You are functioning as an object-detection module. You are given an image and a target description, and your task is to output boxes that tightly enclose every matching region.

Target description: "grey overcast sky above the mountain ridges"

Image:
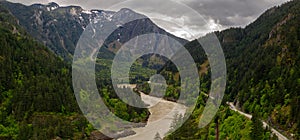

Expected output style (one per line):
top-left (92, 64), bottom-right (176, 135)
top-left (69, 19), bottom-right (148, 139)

top-left (8, 0), bottom-right (288, 40)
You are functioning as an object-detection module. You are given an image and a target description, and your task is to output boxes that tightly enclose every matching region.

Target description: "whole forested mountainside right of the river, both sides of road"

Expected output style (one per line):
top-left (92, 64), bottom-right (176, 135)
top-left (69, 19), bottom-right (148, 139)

top-left (152, 0), bottom-right (300, 139)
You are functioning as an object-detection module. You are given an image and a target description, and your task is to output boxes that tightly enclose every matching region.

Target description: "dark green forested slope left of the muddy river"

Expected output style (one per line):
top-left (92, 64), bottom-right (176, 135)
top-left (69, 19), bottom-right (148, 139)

top-left (0, 4), bottom-right (149, 140)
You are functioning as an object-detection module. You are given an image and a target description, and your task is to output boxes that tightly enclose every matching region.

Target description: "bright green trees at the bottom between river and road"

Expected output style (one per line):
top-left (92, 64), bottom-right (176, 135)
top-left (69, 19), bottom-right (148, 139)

top-left (165, 106), bottom-right (275, 140)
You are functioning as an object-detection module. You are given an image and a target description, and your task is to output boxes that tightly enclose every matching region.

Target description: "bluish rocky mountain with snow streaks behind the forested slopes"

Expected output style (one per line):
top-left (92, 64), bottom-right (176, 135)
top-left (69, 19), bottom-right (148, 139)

top-left (1, 1), bottom-right (187, 60)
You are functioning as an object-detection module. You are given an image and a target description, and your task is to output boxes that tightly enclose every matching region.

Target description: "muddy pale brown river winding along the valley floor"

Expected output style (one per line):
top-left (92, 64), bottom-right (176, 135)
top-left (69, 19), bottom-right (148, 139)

top-left (119, 86), bottom-right (187, 140)
